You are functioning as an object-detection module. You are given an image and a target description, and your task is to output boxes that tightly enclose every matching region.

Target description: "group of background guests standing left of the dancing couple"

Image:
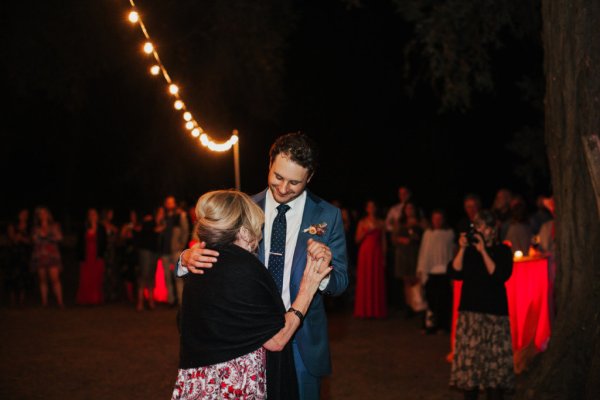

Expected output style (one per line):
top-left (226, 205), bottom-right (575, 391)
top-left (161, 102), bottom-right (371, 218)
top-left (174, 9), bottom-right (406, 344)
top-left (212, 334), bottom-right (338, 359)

top-left (2, 196), bottom-right (194, 310)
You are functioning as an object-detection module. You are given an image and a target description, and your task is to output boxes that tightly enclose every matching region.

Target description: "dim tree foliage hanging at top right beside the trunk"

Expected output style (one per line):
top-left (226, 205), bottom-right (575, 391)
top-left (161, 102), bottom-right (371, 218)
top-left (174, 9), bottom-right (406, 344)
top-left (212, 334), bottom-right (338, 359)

top-left (393, 0), bottom-right (540, 111)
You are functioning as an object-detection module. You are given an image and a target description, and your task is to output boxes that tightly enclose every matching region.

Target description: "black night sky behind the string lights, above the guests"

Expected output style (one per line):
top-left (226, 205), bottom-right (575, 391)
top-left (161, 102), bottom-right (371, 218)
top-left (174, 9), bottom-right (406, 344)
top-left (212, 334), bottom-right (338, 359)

top-left (0, 0), bottom-right (547, 228)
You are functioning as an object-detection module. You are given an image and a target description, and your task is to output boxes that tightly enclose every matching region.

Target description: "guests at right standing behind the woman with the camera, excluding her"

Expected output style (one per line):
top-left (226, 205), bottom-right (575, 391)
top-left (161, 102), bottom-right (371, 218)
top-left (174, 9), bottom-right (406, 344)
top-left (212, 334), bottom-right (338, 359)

top-left (337, 186), bottom-right (554, 334)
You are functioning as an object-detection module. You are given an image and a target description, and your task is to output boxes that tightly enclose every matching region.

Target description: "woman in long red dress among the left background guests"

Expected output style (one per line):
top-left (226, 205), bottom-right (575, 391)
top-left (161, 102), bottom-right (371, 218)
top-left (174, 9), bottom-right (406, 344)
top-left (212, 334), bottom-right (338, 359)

top-left (76, 208), bottom-right (106, 304)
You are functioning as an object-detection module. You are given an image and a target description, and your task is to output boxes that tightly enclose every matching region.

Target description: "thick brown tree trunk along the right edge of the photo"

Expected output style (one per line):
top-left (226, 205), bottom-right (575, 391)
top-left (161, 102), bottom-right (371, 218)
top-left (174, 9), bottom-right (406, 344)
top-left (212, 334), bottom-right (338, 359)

top-left (517, 0), bottom-right (600, 400)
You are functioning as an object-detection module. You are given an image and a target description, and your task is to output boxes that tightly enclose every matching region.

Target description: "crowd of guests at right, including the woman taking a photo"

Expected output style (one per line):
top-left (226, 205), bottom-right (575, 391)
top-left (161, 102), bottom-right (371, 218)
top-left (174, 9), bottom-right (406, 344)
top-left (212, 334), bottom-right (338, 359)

top-left (343, 187), bottom-right (554, 399)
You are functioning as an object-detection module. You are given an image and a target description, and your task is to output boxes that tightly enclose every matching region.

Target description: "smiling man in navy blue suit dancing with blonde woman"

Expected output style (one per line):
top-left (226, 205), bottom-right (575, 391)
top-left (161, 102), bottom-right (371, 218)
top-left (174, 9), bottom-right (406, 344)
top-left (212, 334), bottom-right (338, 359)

top-left (178, 132), bottom-right (348, 400)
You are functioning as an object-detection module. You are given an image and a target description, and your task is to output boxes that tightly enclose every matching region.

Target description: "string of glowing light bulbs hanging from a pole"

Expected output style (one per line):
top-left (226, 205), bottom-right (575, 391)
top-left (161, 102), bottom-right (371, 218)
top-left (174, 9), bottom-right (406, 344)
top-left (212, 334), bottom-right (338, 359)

top-left (128, 0), bottom-right (239, 152)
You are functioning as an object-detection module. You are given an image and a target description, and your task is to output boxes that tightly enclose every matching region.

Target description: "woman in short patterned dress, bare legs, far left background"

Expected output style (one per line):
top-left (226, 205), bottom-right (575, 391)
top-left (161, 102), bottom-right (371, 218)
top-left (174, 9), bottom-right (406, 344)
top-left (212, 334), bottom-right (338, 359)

top-left (31, 207), bottom-right (64, 308)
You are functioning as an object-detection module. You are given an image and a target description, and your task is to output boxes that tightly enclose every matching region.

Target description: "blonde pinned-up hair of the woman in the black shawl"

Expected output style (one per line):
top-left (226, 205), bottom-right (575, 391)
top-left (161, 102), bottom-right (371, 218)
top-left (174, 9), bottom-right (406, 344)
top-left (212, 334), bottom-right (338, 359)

top-left (195, 190), bottom-right (265, 247)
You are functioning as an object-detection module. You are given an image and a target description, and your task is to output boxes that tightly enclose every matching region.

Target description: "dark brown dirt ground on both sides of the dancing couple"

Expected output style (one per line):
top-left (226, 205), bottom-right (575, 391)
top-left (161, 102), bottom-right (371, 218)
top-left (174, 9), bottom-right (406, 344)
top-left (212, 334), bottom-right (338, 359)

top-left (0, 303), bottom-right (510, 400)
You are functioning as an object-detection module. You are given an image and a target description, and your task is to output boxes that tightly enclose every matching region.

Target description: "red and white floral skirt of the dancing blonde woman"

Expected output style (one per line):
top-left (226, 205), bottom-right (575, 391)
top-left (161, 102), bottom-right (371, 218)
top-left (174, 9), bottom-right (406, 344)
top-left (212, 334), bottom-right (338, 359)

top-left (171, 347), bottom-right (267, 400)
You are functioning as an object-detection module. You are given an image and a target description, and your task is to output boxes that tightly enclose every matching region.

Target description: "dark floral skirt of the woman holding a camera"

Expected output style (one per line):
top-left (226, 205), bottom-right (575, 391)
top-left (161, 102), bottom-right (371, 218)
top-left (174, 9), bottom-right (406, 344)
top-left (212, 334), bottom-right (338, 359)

top-left (450, 311), bottom-right (515, 390)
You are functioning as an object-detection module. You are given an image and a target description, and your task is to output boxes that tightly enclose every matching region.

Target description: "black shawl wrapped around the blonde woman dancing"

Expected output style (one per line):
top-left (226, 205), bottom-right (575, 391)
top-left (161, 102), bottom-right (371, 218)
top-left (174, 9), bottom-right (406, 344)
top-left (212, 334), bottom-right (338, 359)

top-left (179, 244), bottom-right (298, 399)
